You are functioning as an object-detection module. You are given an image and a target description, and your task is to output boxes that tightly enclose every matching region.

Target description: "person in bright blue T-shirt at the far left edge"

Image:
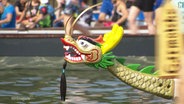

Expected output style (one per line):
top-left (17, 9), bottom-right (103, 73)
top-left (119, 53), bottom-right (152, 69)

top-left (0, 0), bottom-right (16, 28)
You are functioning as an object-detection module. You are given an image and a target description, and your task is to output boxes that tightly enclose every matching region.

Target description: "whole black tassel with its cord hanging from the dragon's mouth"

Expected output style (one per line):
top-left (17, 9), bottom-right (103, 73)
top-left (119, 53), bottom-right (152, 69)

top-left (60, 61), bottom-right (67, 101)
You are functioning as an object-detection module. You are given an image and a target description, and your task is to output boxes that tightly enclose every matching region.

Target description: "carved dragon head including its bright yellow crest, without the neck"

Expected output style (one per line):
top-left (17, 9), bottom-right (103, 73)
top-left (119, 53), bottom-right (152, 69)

top-left (61, 24), bottom-right (123, 67)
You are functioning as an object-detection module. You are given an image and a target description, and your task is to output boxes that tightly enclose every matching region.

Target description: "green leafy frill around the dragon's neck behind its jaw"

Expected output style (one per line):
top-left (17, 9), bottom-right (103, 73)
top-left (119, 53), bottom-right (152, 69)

top-left (87, 52), bottom-right (116, 69)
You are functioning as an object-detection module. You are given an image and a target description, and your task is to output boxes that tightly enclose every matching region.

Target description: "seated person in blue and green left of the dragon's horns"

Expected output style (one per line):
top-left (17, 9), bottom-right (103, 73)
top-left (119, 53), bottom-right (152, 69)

top-left (28, 0), bottom-right (55, 28)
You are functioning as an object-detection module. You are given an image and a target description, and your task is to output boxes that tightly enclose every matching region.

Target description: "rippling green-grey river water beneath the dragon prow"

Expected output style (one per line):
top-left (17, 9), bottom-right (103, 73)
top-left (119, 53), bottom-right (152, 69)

top-left (0, 56), bottom-right (174, 104)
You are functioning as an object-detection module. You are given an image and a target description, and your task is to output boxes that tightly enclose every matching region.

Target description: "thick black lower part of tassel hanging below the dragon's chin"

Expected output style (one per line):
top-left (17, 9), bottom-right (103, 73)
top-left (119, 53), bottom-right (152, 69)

top-left (60, 73), bottom-right (67, 101)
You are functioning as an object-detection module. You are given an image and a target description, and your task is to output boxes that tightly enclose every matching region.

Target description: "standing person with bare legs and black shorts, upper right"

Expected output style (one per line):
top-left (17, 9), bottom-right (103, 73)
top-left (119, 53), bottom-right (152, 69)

top-left (128, 0), bottom-right (155, 35)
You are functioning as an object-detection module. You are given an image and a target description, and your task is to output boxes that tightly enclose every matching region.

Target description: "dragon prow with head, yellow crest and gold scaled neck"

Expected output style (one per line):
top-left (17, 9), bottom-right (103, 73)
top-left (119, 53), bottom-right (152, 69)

top-left (61, 25), bottom-right (175, 99)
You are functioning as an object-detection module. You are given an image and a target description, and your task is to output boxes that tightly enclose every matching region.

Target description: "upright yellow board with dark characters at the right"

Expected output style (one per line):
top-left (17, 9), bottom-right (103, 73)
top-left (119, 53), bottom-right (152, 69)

top-left (155, 0), bottom-right (183, 78)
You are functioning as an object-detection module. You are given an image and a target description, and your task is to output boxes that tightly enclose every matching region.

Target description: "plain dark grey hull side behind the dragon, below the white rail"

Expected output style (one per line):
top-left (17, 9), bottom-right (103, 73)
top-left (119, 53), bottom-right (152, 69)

top-left (0, 35), bottom-right (154, 56)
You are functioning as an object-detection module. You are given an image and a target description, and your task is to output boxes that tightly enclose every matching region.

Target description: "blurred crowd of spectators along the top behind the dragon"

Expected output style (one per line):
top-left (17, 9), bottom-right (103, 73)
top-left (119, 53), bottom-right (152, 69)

top-left (0, 0), bottom-right (162, 34)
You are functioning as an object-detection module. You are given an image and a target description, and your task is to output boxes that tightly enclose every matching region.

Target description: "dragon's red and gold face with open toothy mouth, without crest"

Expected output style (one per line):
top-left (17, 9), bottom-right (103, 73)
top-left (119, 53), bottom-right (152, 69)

top-left (61, 35), bottom-right (102, 63)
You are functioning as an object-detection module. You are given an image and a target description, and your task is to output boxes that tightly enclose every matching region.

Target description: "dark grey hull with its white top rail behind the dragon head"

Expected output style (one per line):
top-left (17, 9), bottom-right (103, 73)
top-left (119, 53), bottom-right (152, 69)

top-left (0, 28), bottom-right (154, 56)
